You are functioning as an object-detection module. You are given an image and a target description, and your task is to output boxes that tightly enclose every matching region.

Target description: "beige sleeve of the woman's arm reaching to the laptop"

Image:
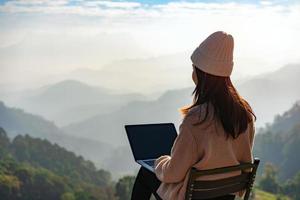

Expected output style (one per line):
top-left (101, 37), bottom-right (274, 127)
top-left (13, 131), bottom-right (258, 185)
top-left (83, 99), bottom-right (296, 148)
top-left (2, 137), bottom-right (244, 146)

top-left (154, 123), bottom-right (197, 183)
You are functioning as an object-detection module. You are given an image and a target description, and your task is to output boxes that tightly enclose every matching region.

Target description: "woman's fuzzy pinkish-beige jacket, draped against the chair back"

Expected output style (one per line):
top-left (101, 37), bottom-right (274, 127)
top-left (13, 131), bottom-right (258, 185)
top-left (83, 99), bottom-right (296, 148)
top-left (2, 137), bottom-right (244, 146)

top-left (155, 104), bottom-right (254, 200)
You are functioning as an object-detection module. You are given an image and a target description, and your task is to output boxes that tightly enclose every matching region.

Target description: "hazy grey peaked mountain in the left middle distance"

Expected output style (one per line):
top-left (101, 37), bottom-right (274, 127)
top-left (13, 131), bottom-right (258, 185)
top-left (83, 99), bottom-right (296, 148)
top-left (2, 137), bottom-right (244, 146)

top-left (2, 80), bottom-right (147, 125)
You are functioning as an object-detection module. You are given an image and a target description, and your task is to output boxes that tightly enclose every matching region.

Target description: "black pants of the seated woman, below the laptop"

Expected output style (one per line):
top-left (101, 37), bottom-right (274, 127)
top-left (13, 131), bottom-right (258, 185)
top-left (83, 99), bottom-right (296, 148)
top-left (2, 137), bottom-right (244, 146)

top-left (131, 167), bottom-right (235, 200)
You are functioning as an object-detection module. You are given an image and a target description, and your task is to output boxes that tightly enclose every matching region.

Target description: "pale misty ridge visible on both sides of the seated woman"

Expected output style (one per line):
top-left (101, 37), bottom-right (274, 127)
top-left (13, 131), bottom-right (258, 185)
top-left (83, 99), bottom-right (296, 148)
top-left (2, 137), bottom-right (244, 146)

top-left (62, 65), bottom-right (300, 144)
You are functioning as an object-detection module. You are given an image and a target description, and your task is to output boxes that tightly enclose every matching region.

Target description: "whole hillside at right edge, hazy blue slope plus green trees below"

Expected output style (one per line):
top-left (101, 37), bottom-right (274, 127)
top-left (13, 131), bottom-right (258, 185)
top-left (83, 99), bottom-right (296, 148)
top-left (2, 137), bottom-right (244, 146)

top-left (254, 102), bottom-right (300, 200)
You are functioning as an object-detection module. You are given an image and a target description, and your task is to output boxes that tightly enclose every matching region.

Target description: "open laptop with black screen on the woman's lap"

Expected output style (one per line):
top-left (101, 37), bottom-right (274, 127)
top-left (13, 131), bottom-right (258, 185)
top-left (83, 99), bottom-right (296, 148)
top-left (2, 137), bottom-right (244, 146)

top-left (125, 123), bottom-right (177, 172)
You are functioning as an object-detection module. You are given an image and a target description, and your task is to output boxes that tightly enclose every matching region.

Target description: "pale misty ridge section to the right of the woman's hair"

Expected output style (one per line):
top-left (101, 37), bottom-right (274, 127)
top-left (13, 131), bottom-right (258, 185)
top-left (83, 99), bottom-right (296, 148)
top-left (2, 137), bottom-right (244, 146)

top-left (236, 64), bottom-right (300, 127)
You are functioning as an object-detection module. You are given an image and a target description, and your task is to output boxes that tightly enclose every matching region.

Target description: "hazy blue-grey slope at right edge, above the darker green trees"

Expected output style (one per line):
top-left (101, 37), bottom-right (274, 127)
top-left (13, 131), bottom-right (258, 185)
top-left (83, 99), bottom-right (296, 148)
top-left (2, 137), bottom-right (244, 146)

top-left (254, 102), bottom-right (300, 180)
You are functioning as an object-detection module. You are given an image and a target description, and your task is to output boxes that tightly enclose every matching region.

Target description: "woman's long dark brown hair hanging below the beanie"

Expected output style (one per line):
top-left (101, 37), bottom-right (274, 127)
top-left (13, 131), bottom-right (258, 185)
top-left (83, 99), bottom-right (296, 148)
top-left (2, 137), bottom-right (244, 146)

top-left (181, 67), bottom-right (256, 138)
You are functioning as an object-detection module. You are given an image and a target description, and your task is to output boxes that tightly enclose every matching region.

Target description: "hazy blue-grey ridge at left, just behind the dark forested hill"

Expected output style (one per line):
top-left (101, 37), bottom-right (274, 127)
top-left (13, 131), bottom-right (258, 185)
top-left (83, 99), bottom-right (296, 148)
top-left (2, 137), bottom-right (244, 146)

top-left (0, 101), bottom-right (112, 170)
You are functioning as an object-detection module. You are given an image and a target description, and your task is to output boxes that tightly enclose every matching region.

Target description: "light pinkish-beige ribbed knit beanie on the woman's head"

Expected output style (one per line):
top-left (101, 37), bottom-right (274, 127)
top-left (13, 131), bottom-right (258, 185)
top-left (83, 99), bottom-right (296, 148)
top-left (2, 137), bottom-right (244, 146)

top-left (191, 31), bottom-right (234, 77)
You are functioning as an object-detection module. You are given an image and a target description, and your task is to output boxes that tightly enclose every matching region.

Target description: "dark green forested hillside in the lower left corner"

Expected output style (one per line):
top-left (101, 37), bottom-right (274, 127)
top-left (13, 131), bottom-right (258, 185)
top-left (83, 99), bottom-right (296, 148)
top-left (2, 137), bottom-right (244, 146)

top-left (0, 128), bottom-right (115, 200)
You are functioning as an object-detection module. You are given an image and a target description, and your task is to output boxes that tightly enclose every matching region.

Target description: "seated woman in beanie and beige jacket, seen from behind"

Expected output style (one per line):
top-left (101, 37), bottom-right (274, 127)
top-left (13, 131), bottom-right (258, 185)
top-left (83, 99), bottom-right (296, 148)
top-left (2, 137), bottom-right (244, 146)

top-left (132, 31), bottom-right (256, 200)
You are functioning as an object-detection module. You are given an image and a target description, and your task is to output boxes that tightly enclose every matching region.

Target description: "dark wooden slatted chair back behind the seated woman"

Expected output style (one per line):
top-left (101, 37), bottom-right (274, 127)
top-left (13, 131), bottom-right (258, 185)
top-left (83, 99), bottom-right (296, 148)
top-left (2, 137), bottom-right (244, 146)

top-left (185, 158), bottom-right (260, 200)
